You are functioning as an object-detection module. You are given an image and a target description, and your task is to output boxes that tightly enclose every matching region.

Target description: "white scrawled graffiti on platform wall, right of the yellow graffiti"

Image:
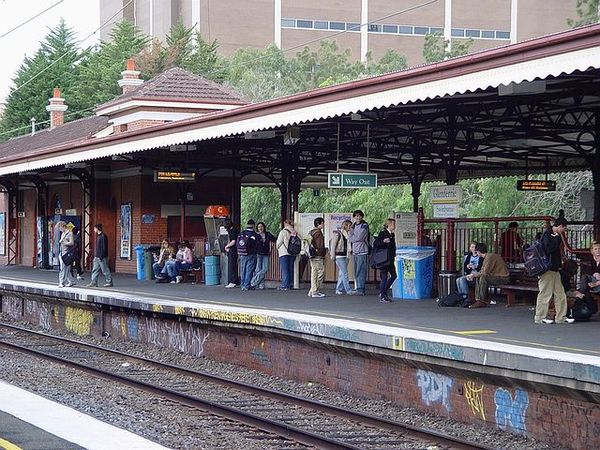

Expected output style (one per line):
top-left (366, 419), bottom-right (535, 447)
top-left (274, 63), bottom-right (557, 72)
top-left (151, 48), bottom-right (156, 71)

top-left (145, 317), bottom-right (209, 356)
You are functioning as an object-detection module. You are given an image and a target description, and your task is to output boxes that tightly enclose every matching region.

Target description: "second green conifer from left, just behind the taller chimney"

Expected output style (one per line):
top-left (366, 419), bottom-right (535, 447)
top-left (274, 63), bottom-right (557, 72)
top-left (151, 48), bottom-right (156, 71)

top-left (73, 20), bottom-right (149, 114)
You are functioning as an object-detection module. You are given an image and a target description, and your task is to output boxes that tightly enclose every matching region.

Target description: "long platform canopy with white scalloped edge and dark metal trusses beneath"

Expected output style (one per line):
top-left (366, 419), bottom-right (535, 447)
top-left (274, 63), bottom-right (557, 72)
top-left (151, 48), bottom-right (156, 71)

top-left (0, 25), bottom-right (600, 185)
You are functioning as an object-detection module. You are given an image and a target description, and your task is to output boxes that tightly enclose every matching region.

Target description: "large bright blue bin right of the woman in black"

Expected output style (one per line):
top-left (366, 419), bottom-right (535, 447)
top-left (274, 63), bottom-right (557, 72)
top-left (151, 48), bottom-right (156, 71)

top-left (392, 246), bottom-right (435, 300)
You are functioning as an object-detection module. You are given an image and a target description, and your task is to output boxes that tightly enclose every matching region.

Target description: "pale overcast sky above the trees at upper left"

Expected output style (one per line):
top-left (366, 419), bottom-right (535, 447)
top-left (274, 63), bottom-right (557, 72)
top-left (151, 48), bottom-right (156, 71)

top-left (0, 0), bottom-right (100, 102)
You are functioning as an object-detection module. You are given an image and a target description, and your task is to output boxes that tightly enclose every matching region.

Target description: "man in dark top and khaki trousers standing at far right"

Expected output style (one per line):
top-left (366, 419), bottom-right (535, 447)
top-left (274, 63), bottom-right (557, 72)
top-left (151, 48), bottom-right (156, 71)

top-left (533, 217), bottom-right (574, 324)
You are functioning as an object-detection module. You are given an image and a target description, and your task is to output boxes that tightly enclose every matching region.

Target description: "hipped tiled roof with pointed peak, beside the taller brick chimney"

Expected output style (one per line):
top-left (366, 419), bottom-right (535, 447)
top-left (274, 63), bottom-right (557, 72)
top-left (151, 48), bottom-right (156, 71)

top-left (97, 67), bottom-right (248, 109)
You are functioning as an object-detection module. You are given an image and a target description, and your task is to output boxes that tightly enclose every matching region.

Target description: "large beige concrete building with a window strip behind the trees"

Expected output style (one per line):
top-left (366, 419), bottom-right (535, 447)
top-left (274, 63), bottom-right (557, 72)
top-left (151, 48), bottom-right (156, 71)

top-left (100, 0), bottom-right (577, 65)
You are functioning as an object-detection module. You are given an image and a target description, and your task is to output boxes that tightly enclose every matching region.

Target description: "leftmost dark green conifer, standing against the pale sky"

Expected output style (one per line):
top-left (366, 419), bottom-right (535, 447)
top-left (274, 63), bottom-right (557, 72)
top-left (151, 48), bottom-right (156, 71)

top-left (0, 20), bottom-right (81, 140)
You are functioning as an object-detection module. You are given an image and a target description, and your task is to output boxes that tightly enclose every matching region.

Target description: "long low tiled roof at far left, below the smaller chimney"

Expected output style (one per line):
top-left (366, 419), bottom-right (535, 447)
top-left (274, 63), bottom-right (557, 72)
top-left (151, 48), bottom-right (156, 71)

top-left (0, 116), bottom-right (108, 160)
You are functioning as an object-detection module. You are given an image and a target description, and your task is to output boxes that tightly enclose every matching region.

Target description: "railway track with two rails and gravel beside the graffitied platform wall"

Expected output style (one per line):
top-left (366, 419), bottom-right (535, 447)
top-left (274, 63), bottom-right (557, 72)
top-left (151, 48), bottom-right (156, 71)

top-left (0, 323), bottom-right (490, 450)
